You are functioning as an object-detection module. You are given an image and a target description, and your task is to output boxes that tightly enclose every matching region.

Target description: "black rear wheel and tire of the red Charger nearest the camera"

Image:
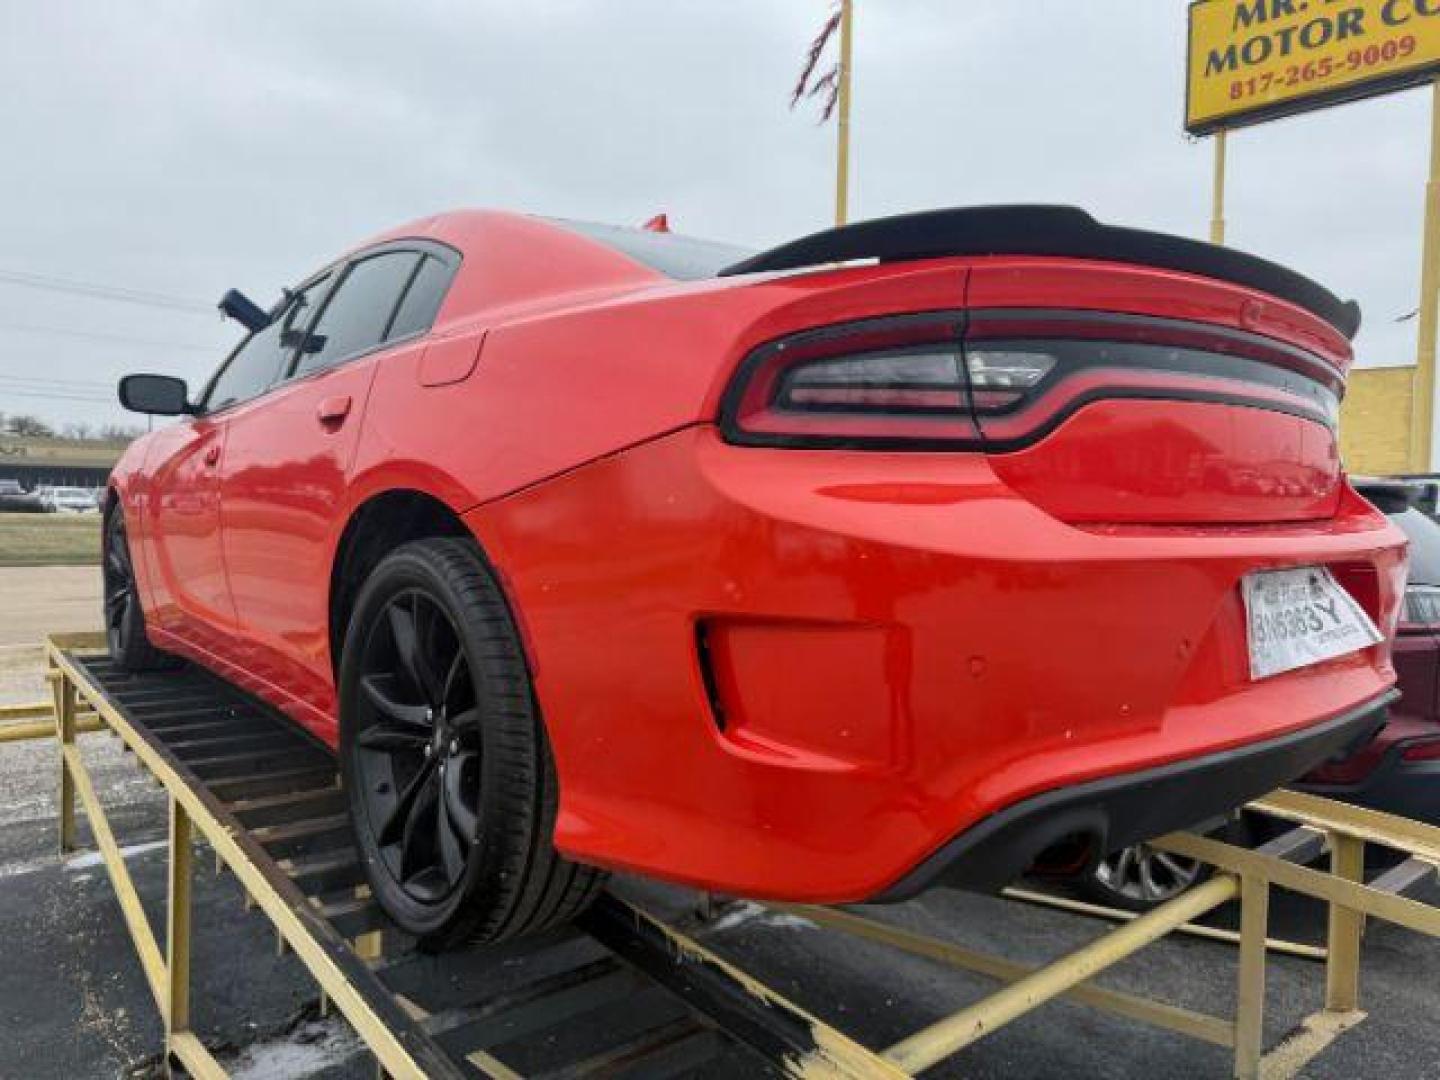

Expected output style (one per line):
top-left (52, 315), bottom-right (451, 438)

top-left (340, 539), bottom-right (606, 952)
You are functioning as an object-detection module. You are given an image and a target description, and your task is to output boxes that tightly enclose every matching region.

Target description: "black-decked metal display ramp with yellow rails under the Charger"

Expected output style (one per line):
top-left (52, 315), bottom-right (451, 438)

top-left (19, 635), bottom-right (1440, 1077)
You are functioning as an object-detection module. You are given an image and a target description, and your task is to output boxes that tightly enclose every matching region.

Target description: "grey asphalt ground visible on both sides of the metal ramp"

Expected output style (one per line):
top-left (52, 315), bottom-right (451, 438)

top-left (0, 572), bottom-right (1440, 1080)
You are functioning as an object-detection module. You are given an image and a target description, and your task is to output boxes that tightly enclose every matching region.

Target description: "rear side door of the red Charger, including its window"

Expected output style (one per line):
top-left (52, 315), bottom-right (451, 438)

top-left (220, 245), bottom-right (443, 734)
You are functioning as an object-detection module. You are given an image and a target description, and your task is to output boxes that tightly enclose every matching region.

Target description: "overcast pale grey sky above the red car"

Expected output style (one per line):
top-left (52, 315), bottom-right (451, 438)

top-left (0, 0), bottom-right (1428, 423)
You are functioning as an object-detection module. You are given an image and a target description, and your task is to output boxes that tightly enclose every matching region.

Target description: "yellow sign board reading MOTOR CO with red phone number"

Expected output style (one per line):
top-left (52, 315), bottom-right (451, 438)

top-left (1185, 0), bottom-right (1440, 135)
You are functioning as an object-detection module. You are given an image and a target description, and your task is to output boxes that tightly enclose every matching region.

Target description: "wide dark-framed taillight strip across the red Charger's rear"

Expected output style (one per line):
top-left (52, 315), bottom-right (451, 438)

top-left (721, 311), bottom-right (1341, 451)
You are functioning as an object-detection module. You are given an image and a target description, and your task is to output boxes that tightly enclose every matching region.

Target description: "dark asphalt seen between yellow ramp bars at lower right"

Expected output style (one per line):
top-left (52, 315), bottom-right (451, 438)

top-left (707, 888), bottom-right (1440, 1080)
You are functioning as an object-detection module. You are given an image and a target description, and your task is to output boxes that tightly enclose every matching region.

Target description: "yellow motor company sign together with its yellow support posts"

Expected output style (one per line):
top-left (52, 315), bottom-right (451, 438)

top-left (1185, 0), bottom-right (1440, 472)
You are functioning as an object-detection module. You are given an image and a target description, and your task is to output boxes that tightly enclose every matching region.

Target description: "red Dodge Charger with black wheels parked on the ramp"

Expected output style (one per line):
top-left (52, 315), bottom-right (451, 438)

top-left (105, 206), bottom-right (1405, 946)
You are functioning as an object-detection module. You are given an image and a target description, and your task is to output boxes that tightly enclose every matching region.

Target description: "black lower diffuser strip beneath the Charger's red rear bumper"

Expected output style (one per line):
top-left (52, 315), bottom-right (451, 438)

top-left (873, 693), bottom-right (1388, 903)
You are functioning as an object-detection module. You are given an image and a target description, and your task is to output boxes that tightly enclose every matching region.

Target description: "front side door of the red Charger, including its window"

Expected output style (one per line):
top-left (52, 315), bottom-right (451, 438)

top-left (144, 292), bottom-right (322, 658)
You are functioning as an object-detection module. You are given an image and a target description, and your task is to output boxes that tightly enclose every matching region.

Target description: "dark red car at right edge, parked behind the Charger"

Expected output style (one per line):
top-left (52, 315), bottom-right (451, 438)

top-left (1073, 478), bottom-right (1440, 910)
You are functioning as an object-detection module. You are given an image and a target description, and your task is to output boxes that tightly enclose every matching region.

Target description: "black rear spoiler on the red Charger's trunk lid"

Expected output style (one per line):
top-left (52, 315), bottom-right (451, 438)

top-left (720, 206), bottom-right (1361, 338)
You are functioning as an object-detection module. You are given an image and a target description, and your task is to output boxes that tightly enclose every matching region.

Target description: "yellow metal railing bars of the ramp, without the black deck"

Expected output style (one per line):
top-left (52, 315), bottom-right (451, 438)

top-left (16, 638), bottom-right (1440, 1079)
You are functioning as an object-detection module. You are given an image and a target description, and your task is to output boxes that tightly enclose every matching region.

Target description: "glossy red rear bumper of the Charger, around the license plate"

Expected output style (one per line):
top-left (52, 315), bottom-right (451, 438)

top-left (467, 428), bottom-right (1404, 903)
